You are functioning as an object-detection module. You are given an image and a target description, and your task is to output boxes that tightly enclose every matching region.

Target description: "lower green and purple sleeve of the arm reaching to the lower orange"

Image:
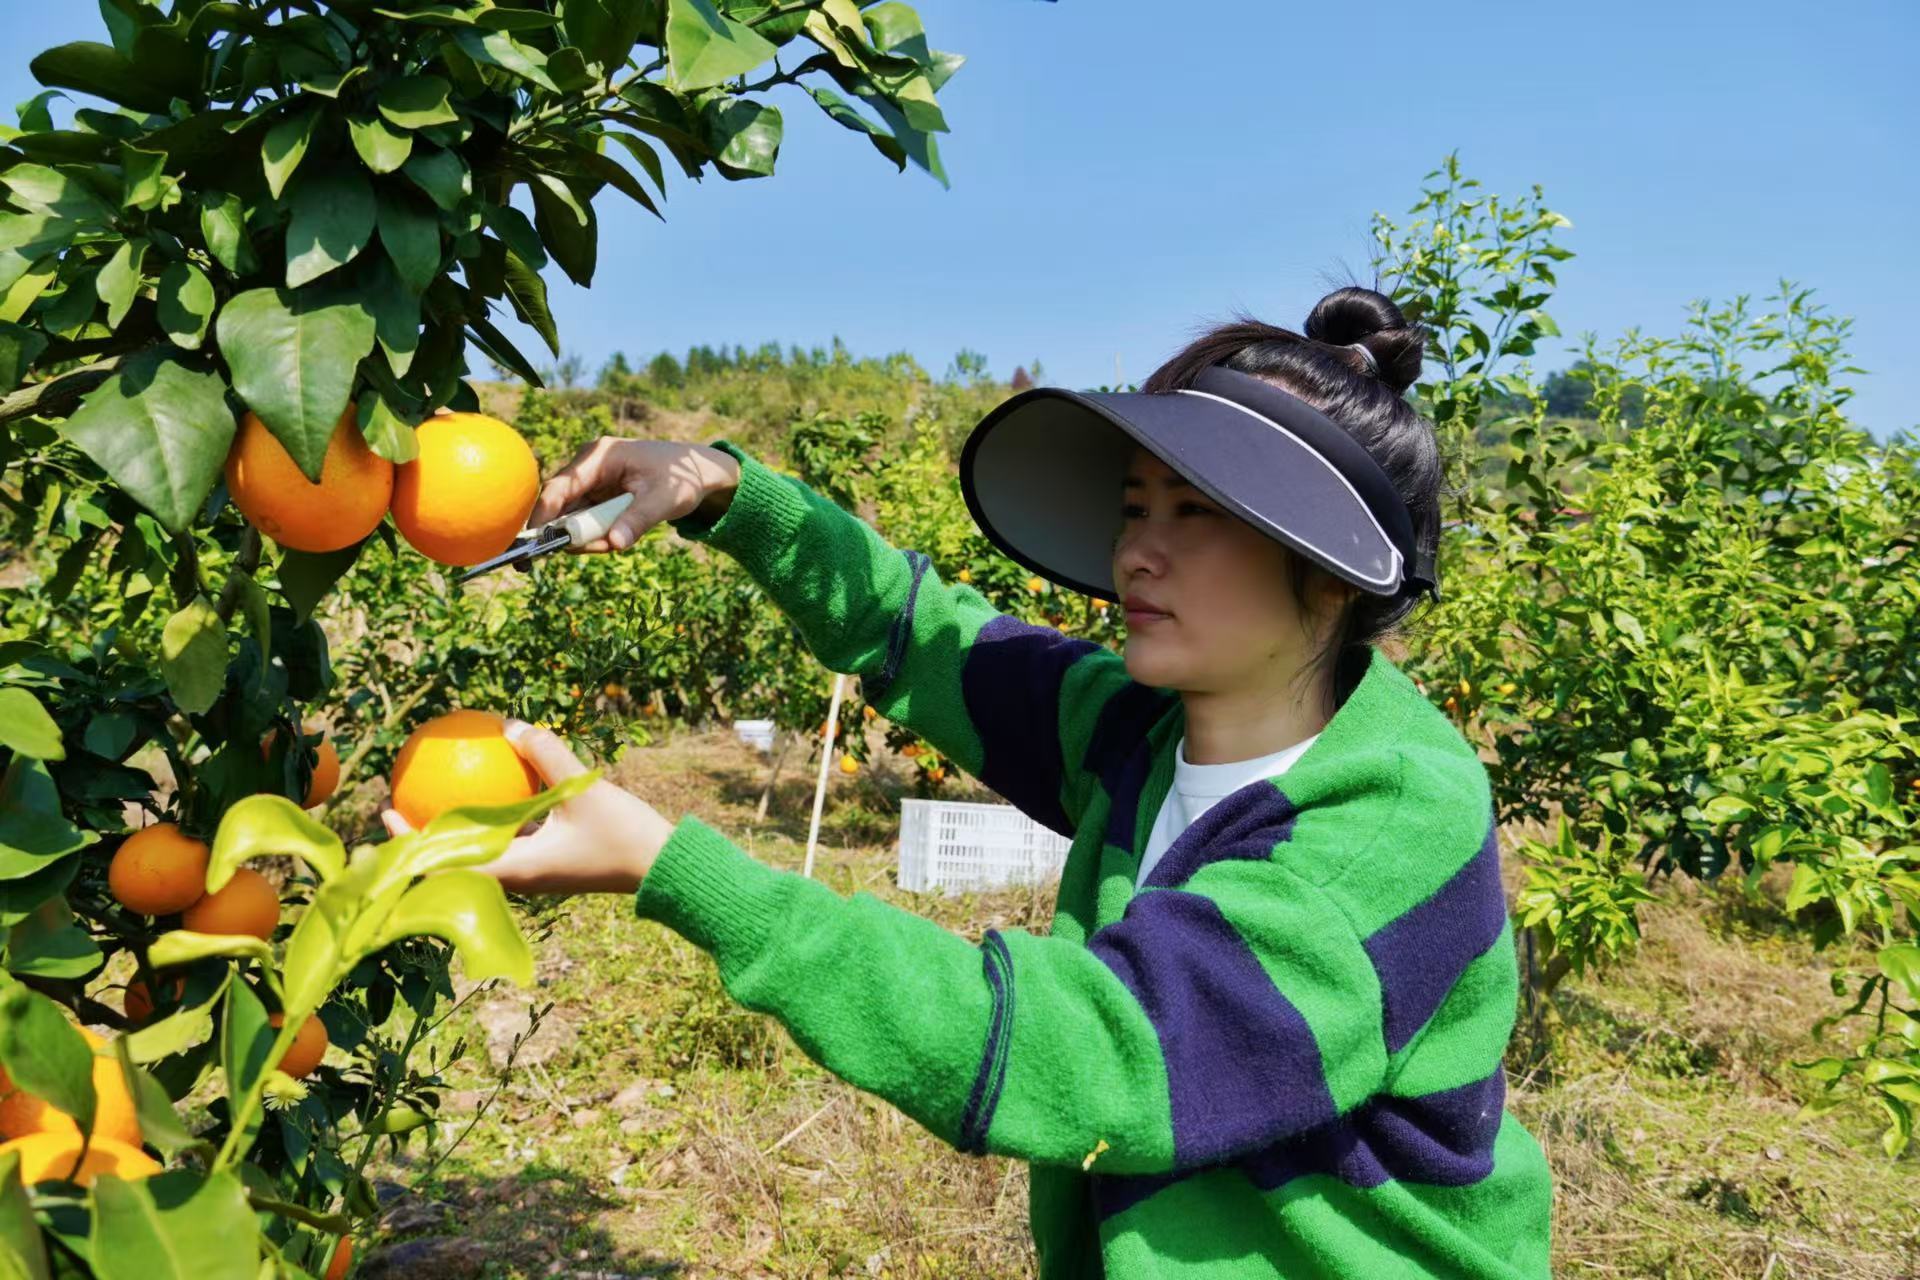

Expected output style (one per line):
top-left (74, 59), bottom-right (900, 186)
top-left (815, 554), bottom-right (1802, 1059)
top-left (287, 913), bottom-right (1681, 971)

top-left (636, 802), bottom-right (1386, 1174)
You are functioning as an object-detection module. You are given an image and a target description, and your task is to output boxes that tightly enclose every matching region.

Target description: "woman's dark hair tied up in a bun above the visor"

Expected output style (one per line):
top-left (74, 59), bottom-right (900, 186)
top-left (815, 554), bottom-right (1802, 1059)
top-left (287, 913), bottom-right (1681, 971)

top-left (1140, 286), bottom-right (1446, 714)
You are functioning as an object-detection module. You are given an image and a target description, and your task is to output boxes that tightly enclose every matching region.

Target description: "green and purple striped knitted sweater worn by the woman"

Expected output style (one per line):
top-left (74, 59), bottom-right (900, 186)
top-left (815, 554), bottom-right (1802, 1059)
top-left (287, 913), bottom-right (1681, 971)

top-left (634, 441), bottom-right (1551, 1280)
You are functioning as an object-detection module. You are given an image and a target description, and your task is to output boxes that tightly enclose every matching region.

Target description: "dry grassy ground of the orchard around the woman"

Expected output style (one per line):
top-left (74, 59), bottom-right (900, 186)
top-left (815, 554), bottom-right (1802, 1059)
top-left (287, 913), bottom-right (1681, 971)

top-left (345, 733), bottom-right (1920, 1280)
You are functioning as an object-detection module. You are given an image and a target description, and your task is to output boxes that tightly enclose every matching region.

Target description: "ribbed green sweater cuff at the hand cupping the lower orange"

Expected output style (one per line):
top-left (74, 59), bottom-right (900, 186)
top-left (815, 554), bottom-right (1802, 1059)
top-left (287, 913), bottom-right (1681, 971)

top-left (634, 814), bottom-right (791, 969)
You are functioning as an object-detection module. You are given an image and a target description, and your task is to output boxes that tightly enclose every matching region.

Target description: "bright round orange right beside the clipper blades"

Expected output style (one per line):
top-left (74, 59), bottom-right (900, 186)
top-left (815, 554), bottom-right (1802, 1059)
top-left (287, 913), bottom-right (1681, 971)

top-left (394, 413), bottom-right (540, 566)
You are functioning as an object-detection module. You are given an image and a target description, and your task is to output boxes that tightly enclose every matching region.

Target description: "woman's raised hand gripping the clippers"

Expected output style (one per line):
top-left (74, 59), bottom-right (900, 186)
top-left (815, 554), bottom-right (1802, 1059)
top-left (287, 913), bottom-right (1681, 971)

top-left (526, 436), bottom-right (739, 555)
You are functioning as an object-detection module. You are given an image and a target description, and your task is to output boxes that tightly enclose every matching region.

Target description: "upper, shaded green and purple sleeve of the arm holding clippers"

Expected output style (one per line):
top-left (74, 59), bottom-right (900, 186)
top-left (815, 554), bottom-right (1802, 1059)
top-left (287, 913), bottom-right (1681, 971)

top-left (674, 439), bottom-right (1173, 835)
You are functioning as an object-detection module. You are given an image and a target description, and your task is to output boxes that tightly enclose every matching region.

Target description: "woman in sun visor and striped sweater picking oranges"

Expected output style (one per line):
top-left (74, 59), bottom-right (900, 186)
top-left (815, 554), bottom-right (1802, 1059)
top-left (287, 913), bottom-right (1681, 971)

top-left (397, 288), bottom-right (1551, 1280)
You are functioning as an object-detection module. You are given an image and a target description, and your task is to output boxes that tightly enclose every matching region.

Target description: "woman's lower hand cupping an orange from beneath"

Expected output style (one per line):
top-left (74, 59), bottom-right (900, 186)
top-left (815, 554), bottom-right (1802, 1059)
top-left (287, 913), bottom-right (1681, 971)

top-left (380, 720), bottom-right (674, 894)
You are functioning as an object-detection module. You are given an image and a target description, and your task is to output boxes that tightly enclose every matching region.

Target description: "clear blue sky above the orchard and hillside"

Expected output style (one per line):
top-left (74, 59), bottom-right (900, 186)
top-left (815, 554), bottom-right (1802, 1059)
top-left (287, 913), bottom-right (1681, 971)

top-left (0, 0), bottom-right (1920, 439)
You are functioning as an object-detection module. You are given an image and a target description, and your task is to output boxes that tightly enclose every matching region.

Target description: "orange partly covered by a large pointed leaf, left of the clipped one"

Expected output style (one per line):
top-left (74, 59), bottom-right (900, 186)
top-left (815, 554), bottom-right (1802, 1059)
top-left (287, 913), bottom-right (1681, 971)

top-left (227, 405), bottom-right (394, 551)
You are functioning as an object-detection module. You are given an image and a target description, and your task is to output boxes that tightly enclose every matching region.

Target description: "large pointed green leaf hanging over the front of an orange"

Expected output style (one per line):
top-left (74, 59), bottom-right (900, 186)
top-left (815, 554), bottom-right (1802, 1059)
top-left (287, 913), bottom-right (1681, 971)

top-left (213, 290), bottom-right (374, 484)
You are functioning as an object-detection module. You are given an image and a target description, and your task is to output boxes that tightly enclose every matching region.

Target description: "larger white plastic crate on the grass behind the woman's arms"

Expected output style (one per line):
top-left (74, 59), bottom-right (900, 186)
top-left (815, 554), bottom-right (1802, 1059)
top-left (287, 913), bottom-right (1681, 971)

top-left (899, 798), bottom-right (1071, 894)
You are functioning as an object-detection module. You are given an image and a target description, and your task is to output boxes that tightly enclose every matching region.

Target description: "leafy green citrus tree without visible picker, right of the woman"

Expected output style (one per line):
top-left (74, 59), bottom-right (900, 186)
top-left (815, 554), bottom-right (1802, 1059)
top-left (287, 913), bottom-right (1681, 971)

top-left (1377, 159), bottom-right (1920, 1155)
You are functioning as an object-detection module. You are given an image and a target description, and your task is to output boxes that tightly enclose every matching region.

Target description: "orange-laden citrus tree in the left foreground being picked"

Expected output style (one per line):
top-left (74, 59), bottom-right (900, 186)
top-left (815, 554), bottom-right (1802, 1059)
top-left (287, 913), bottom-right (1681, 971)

top-left (0, 0), bottom-right (990, 1280)
